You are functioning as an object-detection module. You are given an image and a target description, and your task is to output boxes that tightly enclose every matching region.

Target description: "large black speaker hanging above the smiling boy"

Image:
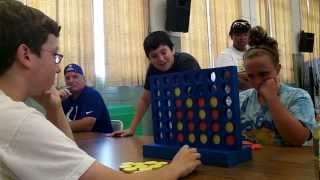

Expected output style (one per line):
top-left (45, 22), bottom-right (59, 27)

top-left (166, 0), bottom-right (191, 32)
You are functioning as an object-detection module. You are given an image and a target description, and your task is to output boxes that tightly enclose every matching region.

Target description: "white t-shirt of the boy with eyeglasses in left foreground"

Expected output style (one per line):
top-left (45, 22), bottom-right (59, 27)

top-left (0, 90), bottom-right (95, 180)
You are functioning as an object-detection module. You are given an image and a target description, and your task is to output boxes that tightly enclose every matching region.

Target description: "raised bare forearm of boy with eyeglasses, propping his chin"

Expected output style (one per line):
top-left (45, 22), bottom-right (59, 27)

top-left (47, 107), bottom-right (73, 139)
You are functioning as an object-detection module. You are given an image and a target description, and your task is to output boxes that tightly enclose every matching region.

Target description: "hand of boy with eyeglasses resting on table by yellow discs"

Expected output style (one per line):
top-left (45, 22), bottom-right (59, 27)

top-left (168, 145), bottom-right (201, 177)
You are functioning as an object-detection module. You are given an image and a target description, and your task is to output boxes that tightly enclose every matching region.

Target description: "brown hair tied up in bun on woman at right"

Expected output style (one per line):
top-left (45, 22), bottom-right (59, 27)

top-left (243, 26), bottom-right (280, 65)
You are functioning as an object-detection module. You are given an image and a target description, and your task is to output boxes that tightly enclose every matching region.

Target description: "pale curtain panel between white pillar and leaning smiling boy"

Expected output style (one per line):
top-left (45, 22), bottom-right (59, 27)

top-left (104, 0), bottom-right (149, 85)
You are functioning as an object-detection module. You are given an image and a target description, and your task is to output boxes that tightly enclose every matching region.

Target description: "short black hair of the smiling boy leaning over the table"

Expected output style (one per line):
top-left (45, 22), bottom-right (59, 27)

top-left (143, 31), bottom-right (173, 58)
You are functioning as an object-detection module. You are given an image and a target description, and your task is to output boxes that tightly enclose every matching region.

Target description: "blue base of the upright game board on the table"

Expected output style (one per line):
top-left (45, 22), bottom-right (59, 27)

top-left (143, 144), bottom-right (252, 167)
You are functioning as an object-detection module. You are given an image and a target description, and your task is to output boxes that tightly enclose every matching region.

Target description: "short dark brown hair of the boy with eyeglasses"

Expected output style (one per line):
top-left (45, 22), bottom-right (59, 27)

top-left (0, 0), bottom-right (60, 75)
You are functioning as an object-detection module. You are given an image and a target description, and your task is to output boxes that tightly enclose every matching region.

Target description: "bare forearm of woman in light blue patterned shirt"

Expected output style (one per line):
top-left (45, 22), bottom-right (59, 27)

top-left (268, 98), bottom-right (309, 145)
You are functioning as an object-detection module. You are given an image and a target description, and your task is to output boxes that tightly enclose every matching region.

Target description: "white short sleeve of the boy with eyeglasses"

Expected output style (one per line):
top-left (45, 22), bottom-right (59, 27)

top-left (3, 111), bottom-right (95, 180)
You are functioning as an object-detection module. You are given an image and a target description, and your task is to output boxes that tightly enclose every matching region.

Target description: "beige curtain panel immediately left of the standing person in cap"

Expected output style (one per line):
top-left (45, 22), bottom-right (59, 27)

top-left (210, 0), bottom-right (241, 62)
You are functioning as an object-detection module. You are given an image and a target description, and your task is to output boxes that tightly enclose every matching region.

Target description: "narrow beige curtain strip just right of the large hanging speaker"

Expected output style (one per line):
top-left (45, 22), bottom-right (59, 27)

top-left (181, 0), bottom-right (209, 68)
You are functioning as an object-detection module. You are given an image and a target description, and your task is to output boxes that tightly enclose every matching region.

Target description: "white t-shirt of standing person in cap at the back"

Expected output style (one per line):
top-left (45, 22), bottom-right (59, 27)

top-left (214, 46), bottom-right (245, 72)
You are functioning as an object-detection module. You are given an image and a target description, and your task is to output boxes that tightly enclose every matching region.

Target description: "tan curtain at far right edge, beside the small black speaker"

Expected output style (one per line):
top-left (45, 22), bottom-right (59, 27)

top-left (300, 0), bottom-right (320, 61)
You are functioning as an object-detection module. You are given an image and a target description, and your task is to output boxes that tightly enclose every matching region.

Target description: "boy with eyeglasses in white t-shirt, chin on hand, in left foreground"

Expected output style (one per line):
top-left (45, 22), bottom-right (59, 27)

top-left (0, 0), bottom-right (201, 180)
